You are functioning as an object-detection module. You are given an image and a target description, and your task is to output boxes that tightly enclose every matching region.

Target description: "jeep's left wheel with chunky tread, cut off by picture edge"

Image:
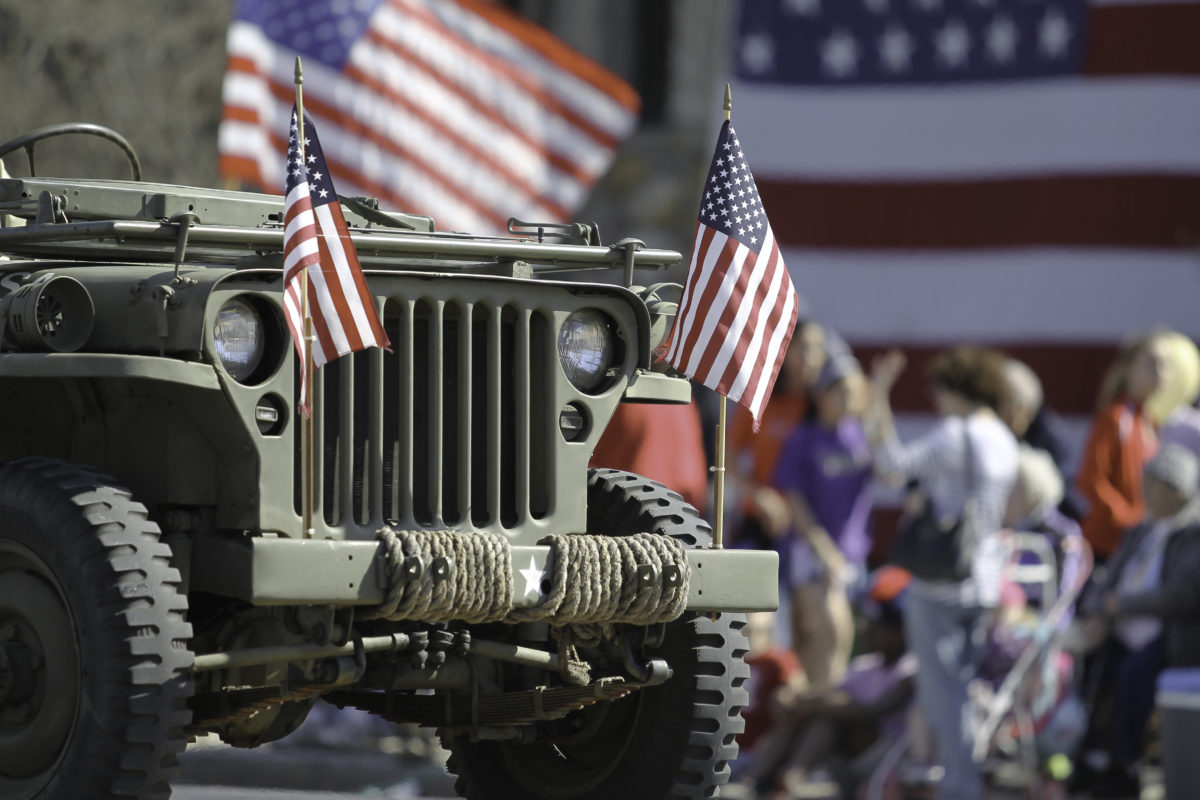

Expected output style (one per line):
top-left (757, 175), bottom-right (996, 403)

top-left (0, 458), bottom-right (192, 800)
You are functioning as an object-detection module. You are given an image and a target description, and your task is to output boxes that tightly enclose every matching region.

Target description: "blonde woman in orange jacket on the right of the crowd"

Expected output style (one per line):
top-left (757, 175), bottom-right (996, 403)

top-left (1078, 333), bottom-right (1169, 560)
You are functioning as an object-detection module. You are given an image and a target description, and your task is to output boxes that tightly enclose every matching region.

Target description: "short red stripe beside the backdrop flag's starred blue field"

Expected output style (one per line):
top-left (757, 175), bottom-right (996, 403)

top-left (1084, 4), bottom-right (1200, 76)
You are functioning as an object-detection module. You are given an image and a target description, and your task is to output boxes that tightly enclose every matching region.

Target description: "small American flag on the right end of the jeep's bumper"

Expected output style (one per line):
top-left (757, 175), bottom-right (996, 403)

top-left (667, 121), bottom-right (799, 427)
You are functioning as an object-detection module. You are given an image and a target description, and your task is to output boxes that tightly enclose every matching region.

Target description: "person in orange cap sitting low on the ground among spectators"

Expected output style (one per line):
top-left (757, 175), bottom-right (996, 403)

top-left (749, 567), bottom-right (917, 796)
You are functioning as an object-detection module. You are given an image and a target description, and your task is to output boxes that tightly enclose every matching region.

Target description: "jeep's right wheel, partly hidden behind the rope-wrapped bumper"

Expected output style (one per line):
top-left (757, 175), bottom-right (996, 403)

top-left (446, 469), bottom-right (750, 800)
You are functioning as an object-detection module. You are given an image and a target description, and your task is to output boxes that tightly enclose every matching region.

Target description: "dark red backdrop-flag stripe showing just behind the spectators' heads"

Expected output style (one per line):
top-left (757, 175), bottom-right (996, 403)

top-left (852, 342), bottom-right (1117, 416)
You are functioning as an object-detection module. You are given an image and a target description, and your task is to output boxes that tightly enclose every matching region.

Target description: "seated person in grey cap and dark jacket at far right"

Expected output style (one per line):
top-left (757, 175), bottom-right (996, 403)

top-left (1076, 445), bottom-right (1200, 798)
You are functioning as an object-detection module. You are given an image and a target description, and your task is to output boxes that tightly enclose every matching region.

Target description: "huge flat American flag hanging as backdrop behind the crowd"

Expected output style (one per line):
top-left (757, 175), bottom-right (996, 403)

top-left (733, 0), bottom-right (1200, 455)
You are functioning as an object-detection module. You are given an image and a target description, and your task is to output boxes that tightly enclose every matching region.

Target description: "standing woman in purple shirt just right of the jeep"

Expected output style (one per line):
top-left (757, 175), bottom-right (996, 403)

top-left (774, 355), bottom-right (871, 688)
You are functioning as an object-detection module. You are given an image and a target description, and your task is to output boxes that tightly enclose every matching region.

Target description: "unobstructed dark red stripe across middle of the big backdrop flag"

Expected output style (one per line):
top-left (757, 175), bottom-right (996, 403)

top-left (757, 175), bottom-right (1200, 249)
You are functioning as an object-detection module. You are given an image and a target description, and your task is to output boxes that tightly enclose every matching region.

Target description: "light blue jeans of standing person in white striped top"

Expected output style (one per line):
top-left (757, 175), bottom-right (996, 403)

top-left (904, 585), bottom-right (984, 800)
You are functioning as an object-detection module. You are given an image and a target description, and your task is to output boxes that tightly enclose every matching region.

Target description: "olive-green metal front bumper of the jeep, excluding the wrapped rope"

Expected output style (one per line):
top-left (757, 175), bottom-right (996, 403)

top-left (189, 536), bottom-right (779, 612)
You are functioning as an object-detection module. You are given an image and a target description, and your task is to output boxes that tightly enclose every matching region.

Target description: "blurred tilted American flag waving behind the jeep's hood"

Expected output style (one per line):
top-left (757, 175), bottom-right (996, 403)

top-left (218, 0), bottom-right (638, 233)
